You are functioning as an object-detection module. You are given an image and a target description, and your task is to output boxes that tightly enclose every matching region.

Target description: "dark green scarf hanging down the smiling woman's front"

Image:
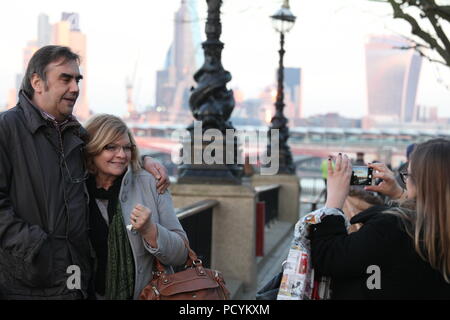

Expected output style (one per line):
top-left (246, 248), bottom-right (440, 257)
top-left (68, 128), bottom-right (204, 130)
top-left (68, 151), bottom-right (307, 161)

top-left (105, 201), bottom-right (135, 300)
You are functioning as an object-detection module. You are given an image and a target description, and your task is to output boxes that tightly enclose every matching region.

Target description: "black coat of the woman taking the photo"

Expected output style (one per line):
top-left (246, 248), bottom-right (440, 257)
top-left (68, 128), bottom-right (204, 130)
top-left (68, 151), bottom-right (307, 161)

top-left (311, 207), bottom-right (450, 299)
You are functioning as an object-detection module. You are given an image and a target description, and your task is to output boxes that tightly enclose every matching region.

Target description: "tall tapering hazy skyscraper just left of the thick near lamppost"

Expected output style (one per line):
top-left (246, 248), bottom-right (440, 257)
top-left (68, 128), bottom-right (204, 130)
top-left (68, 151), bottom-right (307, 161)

top-left (156, 0), bottom-right (203, 122)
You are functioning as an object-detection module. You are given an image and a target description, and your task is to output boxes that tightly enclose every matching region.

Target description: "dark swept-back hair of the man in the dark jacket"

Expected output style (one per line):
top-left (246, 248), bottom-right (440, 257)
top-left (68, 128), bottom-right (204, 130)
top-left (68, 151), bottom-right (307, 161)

top-left (21, 45), bottom-right (80, 98)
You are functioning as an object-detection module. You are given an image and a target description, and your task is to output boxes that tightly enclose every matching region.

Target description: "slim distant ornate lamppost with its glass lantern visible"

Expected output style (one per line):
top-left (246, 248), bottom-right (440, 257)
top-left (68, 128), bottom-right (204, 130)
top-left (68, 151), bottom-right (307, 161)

top-left (267, 0), bottom-right (296, 174)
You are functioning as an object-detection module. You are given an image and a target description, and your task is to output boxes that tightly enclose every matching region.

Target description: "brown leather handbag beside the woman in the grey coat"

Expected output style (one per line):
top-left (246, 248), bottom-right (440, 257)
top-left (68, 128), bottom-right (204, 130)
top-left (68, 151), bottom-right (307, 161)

top-left (139, 243), bottom-right (230, 300)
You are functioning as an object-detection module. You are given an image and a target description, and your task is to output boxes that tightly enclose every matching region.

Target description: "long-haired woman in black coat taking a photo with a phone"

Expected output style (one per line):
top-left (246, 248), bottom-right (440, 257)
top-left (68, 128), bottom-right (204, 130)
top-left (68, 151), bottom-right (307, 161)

top-left (311, 139), bottom-right (450, 299)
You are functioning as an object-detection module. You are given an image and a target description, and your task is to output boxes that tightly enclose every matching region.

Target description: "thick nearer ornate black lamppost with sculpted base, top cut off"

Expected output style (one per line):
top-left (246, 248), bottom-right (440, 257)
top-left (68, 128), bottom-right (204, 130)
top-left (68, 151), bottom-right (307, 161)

top-left (178, 0), bottom-right (243, 184)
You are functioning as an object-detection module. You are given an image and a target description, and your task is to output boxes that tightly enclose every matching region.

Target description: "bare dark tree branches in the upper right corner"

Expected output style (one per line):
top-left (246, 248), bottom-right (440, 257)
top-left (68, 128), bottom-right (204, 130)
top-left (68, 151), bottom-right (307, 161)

top-left (371, 0), bottom-right (450, 67)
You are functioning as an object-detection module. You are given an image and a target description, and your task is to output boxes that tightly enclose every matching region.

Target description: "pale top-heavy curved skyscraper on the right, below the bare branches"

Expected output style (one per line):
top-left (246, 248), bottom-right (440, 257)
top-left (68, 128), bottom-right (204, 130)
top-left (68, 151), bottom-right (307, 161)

top-left (365, 36), bottom-right (422, 127)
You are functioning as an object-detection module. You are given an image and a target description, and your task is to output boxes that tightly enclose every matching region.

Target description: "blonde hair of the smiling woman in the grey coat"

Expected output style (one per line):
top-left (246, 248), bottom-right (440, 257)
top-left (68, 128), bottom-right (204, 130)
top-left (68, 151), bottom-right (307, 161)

top-left (85, 114), bottom-right (141, 174)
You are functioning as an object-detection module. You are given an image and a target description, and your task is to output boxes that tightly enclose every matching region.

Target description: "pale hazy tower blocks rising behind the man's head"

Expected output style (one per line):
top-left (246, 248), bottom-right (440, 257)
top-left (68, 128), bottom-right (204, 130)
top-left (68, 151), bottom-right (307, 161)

top-left (7, 12), bottom-right (90, 121)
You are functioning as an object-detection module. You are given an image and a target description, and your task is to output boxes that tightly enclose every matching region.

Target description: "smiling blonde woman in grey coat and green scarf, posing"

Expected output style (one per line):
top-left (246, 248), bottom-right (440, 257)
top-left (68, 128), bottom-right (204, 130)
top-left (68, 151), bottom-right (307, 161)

top-left (86, 115), bottom-right (187, 299)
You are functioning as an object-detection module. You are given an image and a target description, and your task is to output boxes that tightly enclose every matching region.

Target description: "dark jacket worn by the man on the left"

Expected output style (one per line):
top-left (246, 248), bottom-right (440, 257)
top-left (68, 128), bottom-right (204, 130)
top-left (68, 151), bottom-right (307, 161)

top-left (0, 92), bottom-right (92, 299)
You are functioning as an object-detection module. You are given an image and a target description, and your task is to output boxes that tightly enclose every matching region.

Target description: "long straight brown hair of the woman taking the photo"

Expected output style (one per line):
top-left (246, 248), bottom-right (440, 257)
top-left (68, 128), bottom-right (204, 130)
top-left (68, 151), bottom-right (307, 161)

top-left (388, 139), bottom-right (450, 283)
